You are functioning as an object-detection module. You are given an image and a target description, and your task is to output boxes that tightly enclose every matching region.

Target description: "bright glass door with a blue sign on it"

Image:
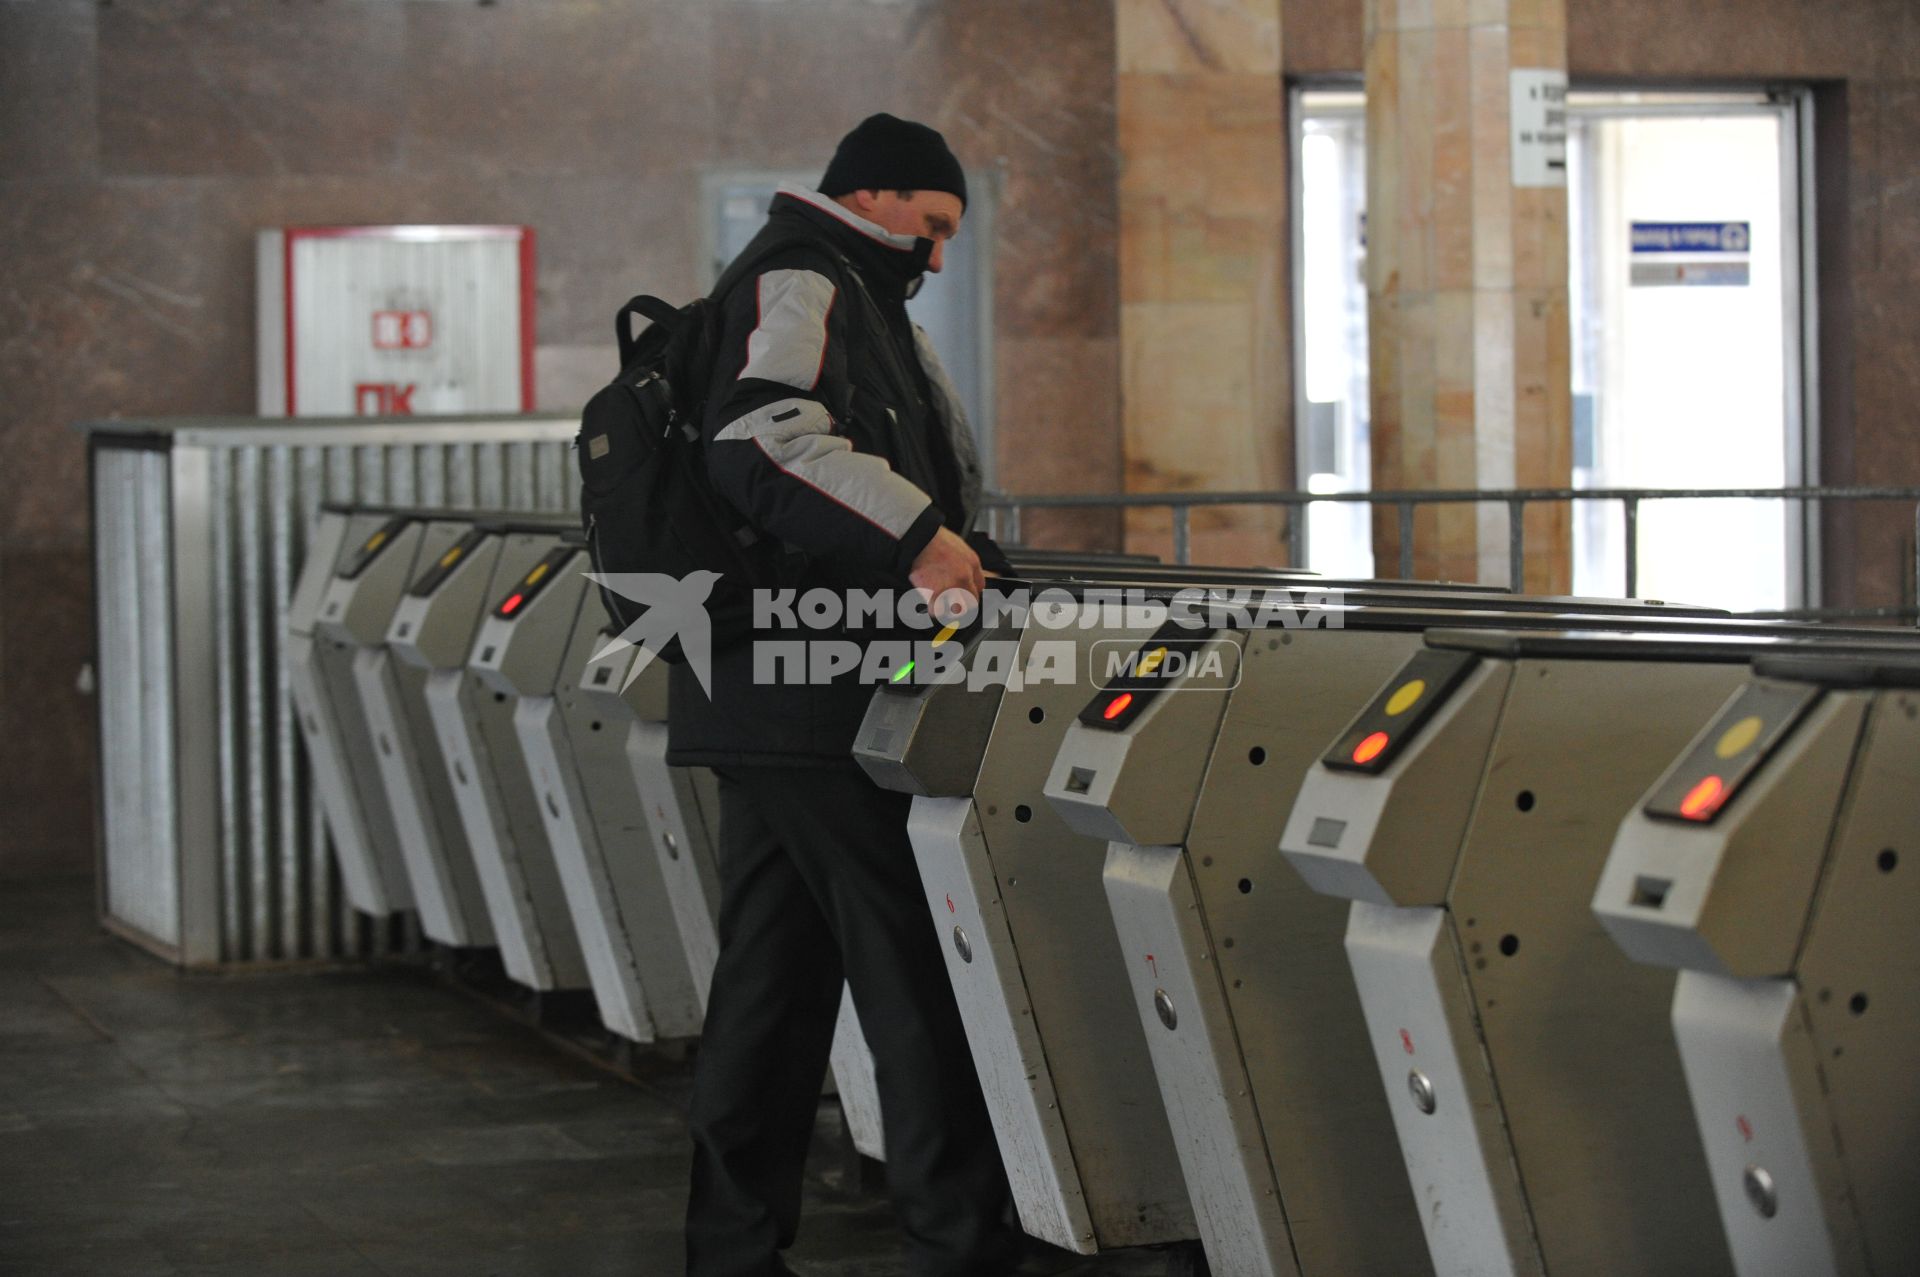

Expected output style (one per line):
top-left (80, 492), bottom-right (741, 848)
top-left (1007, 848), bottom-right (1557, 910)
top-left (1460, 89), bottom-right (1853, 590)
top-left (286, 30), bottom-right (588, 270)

top-left (1567, 92), bottom-right (1811, 609)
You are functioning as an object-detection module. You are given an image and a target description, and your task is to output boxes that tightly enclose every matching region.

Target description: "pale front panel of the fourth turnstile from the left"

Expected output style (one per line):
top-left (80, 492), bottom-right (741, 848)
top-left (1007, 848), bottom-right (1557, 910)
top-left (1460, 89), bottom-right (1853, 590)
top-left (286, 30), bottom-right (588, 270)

top-left (513, 697), bottom-right (655, 1043)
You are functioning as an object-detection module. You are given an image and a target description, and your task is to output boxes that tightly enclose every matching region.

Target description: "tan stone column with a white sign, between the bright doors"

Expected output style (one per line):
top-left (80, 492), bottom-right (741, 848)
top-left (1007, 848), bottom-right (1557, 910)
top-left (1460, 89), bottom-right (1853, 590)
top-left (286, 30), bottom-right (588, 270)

top-left (1365, 0), bottom-right (1572, 591)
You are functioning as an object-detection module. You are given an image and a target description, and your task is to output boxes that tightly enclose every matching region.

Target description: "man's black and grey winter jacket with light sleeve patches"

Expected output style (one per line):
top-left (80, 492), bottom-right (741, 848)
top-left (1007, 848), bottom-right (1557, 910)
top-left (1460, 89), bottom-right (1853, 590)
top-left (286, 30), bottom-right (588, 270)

top-left (668, 184), bottom-right (979, 766)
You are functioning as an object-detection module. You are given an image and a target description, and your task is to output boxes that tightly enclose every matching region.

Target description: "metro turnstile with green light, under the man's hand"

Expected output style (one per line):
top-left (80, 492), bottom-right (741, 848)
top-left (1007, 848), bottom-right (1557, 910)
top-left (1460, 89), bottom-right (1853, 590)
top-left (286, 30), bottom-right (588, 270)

top-left (854, 566), bottom-right (1566, 1252)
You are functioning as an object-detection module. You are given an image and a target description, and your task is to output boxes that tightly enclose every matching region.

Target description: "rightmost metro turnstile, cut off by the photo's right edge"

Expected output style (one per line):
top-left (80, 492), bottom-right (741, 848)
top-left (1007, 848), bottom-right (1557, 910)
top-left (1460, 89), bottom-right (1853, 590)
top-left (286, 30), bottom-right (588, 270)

top-left (1594, 657), bottom-right (1920, 1277)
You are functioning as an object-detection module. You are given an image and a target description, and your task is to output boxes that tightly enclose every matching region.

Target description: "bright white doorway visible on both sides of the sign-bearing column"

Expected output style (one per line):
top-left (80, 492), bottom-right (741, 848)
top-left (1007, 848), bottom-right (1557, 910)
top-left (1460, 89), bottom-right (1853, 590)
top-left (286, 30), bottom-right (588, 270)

top-left (1292, 86), bottom-right (1818, 609)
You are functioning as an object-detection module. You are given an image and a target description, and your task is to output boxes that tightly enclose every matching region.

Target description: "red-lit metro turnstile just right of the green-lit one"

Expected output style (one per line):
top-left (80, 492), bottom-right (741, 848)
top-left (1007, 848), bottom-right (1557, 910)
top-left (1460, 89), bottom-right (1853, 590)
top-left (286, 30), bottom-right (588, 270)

top-left (1046, 588), bottom-right (1743, 1273)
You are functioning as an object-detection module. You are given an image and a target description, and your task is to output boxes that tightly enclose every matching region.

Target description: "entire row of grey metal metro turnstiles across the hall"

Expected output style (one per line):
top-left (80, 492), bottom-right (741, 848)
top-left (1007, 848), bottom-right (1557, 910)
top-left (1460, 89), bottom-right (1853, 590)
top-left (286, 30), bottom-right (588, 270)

top-left (288, 509), bottom-right (1920, 1277)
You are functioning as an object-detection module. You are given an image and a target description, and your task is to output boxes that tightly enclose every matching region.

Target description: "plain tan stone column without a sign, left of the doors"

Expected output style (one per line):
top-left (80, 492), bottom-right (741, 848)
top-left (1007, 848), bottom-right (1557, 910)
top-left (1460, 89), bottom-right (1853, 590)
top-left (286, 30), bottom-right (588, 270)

top-left (1116, 0), bottom-right (1292, 563)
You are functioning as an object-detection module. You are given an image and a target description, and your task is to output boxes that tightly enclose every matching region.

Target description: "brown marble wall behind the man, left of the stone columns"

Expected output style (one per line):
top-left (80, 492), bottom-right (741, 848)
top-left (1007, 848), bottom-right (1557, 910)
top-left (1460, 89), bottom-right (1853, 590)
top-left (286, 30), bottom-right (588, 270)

top-left (0, 0), bottom-right (1121, 876)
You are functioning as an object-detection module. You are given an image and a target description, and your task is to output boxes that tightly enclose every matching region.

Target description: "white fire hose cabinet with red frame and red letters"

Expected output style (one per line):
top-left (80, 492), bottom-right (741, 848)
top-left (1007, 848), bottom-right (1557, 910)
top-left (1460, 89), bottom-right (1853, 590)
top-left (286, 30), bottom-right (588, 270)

top-left (257, 227), bottom-right (534, 417)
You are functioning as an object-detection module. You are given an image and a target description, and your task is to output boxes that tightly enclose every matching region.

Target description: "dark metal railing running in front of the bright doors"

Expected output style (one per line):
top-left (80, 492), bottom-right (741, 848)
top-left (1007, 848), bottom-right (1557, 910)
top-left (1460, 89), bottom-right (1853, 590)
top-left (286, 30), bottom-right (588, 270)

top-left (981, 488), bottom-right (1920, 618)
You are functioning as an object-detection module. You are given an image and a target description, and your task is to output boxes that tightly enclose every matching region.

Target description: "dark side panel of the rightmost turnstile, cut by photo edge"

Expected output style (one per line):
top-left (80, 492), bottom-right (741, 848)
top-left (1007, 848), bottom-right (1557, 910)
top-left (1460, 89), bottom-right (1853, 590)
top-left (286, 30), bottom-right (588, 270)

top-left (1799, 691), bottom-right (1920, 1273)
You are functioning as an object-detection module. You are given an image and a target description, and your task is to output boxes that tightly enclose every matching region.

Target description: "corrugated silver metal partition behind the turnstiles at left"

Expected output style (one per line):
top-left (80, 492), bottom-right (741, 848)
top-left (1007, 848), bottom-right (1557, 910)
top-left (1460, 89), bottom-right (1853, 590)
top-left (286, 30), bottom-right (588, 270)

top-left (86, 417), bottom-right (578, 966)
